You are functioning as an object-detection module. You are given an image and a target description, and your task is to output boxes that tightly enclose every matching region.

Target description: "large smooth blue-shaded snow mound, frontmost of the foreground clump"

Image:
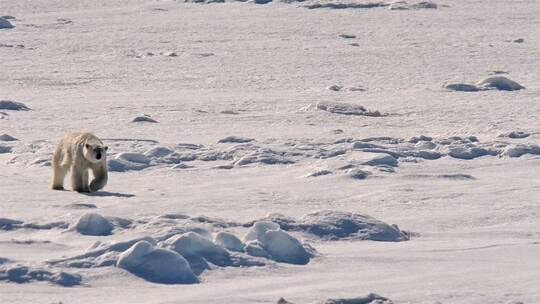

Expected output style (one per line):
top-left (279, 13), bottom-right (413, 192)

top-left (116, 241), bottom-right (199, 284)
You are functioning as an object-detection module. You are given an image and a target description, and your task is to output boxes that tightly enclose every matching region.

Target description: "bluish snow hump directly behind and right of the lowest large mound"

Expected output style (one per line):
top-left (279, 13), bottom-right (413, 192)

top-left (164, 232), bottom-right (231, 266)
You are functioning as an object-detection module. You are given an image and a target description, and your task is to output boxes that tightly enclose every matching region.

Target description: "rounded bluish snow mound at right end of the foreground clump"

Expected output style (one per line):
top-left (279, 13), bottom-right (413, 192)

top-left (244, 221), bottom-right (310, 265)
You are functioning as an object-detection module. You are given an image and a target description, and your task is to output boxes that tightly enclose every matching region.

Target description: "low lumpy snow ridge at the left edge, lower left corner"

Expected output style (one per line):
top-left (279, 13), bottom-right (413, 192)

top-left (0, 265), bottom-right (82, 287)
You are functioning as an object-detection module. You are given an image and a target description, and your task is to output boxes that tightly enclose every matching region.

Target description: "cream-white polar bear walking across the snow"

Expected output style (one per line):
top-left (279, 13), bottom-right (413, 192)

top-left (51, 133), bottom-right (107, 192)
